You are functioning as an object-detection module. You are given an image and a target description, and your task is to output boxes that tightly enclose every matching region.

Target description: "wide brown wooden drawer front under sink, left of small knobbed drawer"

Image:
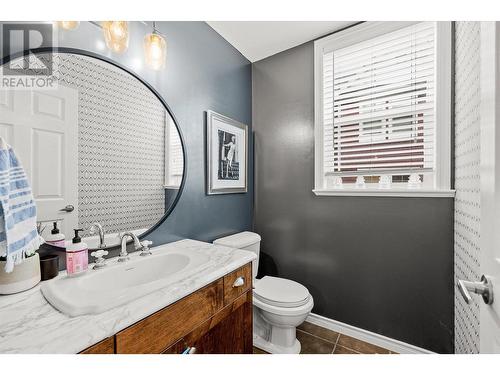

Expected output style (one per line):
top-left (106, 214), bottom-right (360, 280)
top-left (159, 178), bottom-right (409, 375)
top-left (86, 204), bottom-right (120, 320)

top-left (116, 279), bottom-right (224, 354)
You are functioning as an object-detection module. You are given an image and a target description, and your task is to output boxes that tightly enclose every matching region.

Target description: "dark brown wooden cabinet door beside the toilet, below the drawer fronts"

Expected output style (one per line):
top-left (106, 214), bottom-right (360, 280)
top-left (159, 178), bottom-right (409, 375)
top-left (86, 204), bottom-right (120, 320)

top-left (164, 291), bottom-right (253, 354)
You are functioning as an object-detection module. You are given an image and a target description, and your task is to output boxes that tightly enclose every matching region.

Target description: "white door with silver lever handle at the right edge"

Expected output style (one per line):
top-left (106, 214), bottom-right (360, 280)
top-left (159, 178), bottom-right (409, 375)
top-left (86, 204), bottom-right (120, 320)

top-left (480, 22), bottom-right (500, 353)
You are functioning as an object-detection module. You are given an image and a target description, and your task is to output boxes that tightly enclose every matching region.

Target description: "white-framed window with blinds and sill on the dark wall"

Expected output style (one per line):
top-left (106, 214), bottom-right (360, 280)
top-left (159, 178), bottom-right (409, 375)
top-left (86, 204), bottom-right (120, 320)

top-left (314, 22), bottom-right (453, 196)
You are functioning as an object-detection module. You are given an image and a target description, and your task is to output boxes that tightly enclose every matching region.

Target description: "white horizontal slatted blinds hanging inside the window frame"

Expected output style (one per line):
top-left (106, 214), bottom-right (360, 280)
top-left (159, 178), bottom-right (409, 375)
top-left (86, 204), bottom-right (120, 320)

top-left (322, 22), bottom-right (435, 182)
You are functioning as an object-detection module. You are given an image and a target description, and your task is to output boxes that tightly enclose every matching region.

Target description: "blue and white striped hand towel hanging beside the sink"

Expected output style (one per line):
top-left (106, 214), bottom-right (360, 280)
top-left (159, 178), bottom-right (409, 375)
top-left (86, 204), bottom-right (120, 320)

top-left (0, 137), bottom-right (44, 272)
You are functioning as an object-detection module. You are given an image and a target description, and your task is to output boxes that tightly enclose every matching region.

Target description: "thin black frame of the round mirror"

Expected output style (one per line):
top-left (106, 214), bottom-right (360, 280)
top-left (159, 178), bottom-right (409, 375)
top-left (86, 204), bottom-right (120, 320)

top-left (0, 47), bottom-right (187, 245)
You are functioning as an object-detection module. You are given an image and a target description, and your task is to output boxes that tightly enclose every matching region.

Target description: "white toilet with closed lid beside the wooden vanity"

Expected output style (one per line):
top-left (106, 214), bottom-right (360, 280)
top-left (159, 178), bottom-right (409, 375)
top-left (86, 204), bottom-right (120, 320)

top-left (214, 232), bottom-right (314, 354)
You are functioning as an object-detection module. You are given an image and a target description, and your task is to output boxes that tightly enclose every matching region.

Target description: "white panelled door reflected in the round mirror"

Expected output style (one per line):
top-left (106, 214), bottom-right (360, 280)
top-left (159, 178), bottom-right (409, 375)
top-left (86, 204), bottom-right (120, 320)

top-left (0, 85), bottom-right (78, 238)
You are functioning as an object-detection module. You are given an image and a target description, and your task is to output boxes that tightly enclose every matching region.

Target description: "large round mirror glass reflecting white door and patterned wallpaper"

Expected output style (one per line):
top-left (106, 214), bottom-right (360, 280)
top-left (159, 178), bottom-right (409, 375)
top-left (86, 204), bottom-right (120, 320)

top-left (0, 49), bottom-right (184, 248)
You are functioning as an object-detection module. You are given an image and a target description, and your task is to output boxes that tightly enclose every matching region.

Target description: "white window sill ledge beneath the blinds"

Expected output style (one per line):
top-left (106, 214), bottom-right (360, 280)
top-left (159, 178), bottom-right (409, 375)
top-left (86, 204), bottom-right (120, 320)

top-left (313, 189), bottom-right (455, 198)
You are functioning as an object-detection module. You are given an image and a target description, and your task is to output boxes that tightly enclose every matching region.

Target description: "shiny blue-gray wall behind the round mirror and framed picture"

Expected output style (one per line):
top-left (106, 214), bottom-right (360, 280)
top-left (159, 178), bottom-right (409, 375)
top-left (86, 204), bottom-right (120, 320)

top-left (0, 22), bottom-right (253, 244)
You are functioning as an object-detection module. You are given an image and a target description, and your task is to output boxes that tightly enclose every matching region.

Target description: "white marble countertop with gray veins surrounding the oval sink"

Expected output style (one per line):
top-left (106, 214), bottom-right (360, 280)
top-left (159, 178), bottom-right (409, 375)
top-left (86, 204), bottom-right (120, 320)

top-left (0, 240), bottom-right (256, 354)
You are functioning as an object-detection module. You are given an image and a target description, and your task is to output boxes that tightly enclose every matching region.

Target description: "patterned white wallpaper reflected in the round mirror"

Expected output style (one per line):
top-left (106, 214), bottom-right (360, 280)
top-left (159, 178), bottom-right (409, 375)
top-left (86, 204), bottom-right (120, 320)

top-left (42, 54), bottom-right (168, 233)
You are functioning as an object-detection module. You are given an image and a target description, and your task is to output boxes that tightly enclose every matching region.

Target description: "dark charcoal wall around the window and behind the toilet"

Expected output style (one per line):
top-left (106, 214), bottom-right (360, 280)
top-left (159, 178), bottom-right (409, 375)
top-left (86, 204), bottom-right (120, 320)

top-left (252, 42), bottom-right (454, 353)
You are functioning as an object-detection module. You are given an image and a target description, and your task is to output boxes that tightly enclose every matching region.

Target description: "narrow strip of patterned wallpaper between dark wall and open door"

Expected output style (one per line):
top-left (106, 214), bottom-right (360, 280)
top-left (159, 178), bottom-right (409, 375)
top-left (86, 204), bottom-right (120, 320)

top-left (455, 22), bottom-right (481, 353)
